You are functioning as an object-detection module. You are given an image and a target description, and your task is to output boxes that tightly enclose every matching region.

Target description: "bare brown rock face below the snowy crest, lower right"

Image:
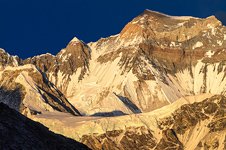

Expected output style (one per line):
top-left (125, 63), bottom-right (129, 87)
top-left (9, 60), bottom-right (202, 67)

top-left (78, 95), bottom-right (226, 150)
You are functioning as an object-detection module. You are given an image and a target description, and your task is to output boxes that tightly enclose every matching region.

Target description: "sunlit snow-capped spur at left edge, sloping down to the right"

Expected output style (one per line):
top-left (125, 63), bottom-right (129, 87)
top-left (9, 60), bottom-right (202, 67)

top-left (0, 50), bottom-right (80, 116)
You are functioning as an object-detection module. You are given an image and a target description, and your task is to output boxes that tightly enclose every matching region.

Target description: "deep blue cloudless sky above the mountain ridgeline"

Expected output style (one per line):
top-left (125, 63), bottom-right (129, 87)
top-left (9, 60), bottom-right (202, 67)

top-left (0, 0), bottom-right (226, 58)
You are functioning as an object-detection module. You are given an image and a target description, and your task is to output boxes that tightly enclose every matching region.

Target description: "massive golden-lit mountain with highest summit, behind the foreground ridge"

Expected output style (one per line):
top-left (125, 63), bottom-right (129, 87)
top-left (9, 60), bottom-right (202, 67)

top-left (24, 10), bottom-right (226, 115)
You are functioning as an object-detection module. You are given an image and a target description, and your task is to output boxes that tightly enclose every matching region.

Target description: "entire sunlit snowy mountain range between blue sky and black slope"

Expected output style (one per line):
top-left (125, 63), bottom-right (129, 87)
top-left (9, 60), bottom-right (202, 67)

top-left (0, 10), bottom-right (226, 149)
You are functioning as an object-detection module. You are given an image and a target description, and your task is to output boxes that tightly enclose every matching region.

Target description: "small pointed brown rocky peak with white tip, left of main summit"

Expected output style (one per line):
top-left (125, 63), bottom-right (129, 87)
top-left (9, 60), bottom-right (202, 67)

top-left (24, 37), bottom-right (91, 94)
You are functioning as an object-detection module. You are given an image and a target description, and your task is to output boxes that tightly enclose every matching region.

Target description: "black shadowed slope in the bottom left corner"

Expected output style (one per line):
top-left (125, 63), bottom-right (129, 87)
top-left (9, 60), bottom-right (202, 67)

top-left (0, 103), bottom-right (89, 150)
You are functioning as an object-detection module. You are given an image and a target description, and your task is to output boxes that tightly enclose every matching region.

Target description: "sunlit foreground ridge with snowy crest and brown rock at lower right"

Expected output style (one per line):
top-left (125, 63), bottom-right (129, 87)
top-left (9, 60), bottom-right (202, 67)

top-left (30, 94), bottom-right (226, 150)
